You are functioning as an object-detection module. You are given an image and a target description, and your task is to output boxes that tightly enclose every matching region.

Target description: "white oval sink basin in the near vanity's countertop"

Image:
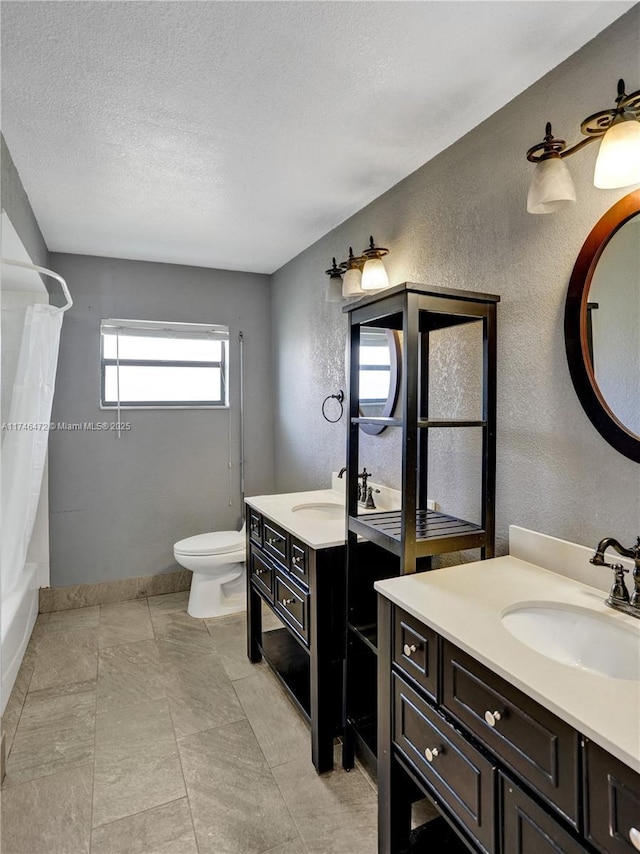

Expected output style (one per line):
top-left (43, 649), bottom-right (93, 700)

top-left (501, 602), bottom-right (640, 680)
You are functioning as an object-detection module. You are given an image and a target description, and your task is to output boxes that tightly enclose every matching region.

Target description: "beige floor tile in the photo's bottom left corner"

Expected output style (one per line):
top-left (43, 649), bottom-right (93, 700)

top-left (0, 765), bottom-right (93, 854)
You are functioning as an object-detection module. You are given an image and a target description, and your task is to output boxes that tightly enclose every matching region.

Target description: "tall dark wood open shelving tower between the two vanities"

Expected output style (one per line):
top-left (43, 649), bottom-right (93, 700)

top-left (342, 282), bottom-right (500, 768)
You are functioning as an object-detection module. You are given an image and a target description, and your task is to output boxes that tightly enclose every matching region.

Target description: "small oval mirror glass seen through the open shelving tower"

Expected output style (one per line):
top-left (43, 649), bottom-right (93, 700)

top-left (359, 326), bottom-right (400, 436)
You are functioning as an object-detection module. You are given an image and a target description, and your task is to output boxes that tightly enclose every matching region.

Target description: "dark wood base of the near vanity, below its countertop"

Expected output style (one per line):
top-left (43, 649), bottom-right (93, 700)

top-left (378, 596), bottom-right (640, 854)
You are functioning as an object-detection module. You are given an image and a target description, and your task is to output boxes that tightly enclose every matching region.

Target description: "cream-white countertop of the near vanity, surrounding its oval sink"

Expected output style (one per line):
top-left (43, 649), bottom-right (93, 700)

top-left (375, 556), bottom-right (640, 772)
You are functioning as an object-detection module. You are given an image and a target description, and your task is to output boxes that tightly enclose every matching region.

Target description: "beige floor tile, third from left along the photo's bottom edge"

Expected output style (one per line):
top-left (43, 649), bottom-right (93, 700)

top-left (178, 721), bottom-right (298, 854)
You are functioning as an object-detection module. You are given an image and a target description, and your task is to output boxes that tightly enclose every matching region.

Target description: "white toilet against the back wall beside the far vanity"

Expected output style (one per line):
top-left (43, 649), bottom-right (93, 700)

top-left (173, 525), bottom-right (247, 618)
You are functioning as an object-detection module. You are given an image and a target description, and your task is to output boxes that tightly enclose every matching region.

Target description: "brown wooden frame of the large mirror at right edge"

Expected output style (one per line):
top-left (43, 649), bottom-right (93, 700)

top-left (564, 190), bottom-right (640, 463)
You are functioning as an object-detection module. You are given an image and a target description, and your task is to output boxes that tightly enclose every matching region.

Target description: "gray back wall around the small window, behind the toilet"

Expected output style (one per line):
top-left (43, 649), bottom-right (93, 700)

top-left (49, 254), bottom-right (273, 587)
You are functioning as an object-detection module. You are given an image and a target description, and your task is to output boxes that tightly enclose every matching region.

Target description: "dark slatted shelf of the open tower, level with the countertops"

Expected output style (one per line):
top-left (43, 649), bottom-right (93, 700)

top-left (349, 510), bottom-right (486, 557)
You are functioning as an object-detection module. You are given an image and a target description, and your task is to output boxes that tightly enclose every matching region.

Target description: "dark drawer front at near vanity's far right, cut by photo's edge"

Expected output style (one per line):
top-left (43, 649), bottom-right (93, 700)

top-left (584, 740), bottom-right (640, 854)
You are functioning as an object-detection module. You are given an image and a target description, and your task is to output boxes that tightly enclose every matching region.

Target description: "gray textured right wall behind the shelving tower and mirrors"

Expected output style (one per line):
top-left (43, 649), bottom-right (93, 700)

top-left (272, 6), bottom-right (640, 552)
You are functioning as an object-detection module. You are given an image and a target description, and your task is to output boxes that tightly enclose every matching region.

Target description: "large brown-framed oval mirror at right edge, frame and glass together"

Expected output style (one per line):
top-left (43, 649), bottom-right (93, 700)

top-left (564, 190), bottom-right (640, 462)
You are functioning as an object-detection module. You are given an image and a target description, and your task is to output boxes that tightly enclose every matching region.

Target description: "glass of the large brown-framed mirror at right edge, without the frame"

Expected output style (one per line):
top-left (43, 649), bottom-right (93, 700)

top-left (587, 214), bottom-right (640, 436)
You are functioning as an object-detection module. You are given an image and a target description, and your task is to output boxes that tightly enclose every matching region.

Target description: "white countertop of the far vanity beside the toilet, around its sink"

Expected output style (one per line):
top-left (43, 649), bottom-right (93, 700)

top-left (245, 489), bottom-right (346, 549)
